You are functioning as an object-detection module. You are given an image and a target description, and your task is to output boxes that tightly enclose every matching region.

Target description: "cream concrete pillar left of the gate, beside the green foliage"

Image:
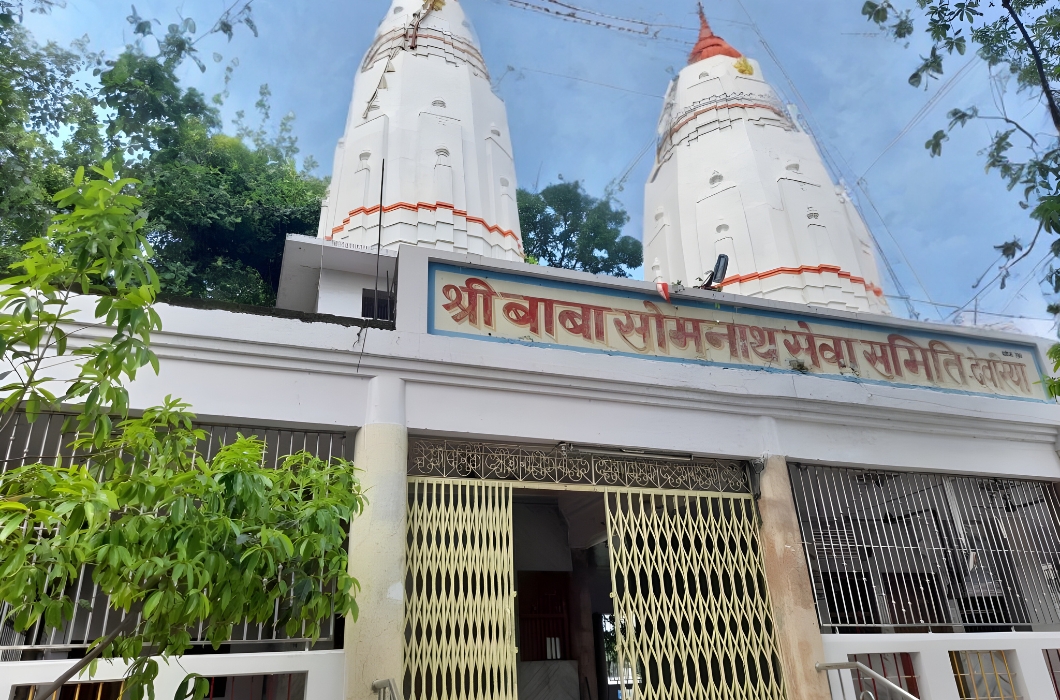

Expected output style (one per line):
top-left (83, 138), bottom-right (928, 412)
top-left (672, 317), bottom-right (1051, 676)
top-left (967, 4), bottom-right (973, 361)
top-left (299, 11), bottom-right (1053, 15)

top-left (343, 377), bottom-right (408, 700)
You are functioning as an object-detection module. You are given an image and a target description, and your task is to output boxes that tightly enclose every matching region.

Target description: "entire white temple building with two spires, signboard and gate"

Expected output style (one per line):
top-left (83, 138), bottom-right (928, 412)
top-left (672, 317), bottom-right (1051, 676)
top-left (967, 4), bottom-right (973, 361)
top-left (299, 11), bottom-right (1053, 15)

top-left (0, 0), bottom-right (1060, 700)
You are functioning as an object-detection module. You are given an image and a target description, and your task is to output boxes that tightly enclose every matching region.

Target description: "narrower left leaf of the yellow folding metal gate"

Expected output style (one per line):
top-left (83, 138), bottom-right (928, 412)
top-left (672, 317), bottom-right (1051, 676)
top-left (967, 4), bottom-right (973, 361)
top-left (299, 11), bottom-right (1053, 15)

top-left (403, 478), bottom-right (517, 700)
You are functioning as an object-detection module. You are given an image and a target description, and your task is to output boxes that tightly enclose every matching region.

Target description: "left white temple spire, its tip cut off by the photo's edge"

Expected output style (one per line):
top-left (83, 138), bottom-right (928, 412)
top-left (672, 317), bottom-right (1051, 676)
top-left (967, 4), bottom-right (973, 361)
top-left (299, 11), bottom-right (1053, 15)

top-left (318, 0), bottom-right (523, 260)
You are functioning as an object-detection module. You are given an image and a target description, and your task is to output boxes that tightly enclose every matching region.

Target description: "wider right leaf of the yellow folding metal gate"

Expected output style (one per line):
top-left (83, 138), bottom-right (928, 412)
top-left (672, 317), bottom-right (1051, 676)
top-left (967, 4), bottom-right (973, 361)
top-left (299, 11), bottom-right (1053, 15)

top-left (606, 490), bottom-right (784, 700)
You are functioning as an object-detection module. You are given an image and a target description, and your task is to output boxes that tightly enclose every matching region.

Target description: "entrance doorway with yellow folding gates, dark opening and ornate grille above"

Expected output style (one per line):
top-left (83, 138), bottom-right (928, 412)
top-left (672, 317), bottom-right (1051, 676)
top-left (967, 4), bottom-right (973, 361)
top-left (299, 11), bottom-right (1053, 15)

top-left (402, 439), bottom-right (785, 700)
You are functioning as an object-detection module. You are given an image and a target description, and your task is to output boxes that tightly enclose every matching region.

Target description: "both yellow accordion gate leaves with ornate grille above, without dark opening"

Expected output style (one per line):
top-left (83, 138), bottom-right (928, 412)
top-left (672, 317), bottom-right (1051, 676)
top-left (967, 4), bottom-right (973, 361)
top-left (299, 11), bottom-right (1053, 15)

top-left (403, 440), bottom-right (785, 700)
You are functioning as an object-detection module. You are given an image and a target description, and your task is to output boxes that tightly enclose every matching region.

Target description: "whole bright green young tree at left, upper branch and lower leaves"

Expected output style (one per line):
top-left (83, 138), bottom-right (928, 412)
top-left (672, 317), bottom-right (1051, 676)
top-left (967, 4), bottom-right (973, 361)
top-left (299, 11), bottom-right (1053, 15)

top-left (0, 162), bottom-right (366, 700)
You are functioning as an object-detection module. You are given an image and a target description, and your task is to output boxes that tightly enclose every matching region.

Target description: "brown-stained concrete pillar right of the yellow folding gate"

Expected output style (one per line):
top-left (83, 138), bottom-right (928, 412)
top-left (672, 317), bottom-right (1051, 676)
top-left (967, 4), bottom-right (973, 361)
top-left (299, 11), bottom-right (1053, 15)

top-left (758, 456), bottom-right (830, 700)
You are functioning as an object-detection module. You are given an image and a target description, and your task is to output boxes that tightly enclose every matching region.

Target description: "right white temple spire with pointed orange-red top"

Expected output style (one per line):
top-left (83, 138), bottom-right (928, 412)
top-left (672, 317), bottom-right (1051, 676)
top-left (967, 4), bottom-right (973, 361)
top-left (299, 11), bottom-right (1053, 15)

top-left (644, 7), bottom-right (889, 313)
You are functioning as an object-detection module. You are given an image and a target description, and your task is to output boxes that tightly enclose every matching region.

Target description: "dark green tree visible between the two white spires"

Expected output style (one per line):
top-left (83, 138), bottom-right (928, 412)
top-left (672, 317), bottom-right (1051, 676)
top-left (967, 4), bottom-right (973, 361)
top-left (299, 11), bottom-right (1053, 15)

top-left (516, 180), bottom-right (643, 277)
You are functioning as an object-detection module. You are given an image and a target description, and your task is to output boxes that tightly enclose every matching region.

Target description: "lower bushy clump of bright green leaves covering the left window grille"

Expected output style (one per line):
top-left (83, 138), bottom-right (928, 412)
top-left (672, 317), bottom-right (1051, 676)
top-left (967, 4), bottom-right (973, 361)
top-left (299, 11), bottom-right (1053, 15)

top-left (0, 398), bottom-right (365, 700)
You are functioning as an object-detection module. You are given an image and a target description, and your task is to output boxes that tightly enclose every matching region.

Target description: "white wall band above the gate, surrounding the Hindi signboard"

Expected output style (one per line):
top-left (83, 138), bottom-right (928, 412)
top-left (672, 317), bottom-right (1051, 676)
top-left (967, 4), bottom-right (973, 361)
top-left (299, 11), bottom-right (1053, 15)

top-left (43, 242), bottom-right (1060, 478)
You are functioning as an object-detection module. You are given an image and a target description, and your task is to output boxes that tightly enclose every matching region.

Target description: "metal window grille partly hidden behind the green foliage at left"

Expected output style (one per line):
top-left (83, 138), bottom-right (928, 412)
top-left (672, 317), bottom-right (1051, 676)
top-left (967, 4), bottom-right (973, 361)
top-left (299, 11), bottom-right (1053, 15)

top-left (0, 414), bottom-right (346, 661)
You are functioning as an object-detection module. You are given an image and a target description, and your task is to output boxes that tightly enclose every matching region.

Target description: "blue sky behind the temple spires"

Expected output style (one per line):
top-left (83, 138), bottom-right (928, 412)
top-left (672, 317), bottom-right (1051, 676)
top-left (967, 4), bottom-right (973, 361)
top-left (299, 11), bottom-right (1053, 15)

top-left (27, 0), bottom-right (1052, 335)
